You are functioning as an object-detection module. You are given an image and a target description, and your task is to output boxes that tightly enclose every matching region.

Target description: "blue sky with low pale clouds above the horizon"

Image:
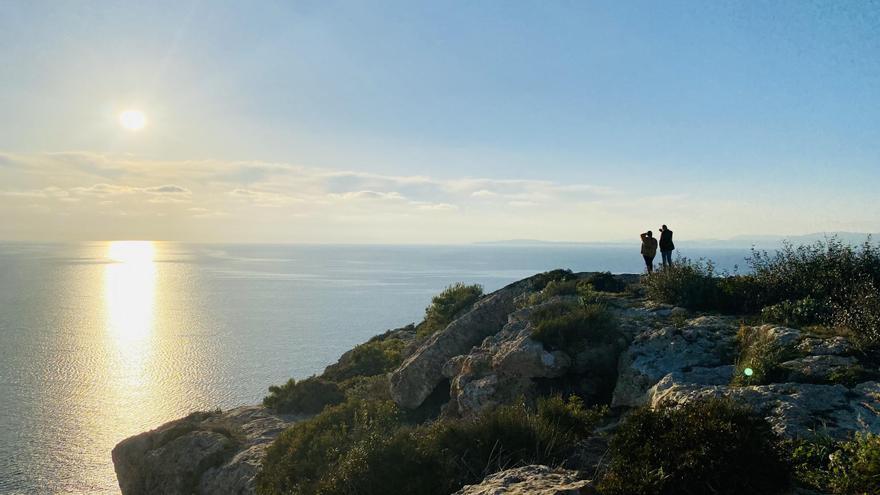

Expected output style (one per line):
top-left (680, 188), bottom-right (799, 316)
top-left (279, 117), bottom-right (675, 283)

top-left (0, 0), bottom-right (880, 243)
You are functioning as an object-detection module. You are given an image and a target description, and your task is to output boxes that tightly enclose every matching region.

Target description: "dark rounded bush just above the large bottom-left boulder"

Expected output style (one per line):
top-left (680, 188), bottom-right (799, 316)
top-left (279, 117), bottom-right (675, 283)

top-left (263, 376), bottom-right (345, 414)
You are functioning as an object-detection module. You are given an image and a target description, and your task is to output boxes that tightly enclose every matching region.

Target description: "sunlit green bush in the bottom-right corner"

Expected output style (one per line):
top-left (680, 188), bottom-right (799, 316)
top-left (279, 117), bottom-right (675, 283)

top-left (787, 433), bottom-right (880, 495)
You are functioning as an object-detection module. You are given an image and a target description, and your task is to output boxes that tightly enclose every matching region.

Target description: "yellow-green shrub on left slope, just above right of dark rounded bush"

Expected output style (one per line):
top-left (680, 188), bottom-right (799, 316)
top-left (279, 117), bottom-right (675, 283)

top-left (322, 337), bottom-right (406, 382)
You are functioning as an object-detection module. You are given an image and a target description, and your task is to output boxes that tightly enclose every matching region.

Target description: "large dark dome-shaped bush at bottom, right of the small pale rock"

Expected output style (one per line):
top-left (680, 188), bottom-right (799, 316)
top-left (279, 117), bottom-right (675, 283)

top-left (599, 399), bottom-right (789, 495)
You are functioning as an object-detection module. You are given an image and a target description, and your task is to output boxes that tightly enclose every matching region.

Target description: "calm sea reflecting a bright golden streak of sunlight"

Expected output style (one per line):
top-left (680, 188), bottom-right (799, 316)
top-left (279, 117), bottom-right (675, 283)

top-left (0, 241), bottom-right (747, 493)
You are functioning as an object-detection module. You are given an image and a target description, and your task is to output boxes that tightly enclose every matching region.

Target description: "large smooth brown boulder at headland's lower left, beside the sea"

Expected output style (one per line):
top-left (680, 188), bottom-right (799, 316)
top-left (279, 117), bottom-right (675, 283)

top-left (112, 406), bottom-right (297, 495)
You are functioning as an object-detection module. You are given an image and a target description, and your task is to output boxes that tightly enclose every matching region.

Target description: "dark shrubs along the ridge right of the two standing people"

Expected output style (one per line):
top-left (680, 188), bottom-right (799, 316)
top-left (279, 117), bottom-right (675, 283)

top-left (643, 238), bottom-right (880, 351)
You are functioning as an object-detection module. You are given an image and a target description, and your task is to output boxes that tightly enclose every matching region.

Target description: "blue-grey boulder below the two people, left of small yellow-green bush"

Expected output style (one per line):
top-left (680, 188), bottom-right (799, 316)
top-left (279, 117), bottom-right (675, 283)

top-left (611, 316), bottom-right (737, 407)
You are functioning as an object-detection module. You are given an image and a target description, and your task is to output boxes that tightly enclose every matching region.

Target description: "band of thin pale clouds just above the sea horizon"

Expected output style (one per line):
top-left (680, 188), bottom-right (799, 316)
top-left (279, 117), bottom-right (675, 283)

top-left (0, 152), bottom-right (880, 243)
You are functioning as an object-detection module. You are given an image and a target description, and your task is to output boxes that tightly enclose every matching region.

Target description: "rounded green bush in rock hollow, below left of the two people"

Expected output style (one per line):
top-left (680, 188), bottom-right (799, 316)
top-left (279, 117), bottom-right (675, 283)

top-left (531, 303), bottom-right (619, 354)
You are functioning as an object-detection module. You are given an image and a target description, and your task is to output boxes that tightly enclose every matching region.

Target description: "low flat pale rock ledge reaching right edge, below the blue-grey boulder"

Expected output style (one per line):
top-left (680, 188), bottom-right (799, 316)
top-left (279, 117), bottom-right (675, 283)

top-left (648, 374), bottom-right (880, 439)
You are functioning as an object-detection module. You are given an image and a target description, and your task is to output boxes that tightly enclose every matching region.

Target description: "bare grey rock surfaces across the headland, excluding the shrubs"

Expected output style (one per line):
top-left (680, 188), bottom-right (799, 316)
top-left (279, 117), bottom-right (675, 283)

top-left (113, 274), bottom-right (880, 495)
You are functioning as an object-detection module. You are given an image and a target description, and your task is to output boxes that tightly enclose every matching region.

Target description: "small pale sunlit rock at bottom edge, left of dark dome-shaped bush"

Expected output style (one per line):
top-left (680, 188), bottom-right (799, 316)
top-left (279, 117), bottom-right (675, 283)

top-left (453, 465), bottom-right (596, 495)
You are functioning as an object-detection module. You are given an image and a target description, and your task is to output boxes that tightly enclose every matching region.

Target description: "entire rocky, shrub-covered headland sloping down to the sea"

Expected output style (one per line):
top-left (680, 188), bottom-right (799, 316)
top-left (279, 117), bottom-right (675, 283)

top-left (113, 236), bottom-right (880, 495)
